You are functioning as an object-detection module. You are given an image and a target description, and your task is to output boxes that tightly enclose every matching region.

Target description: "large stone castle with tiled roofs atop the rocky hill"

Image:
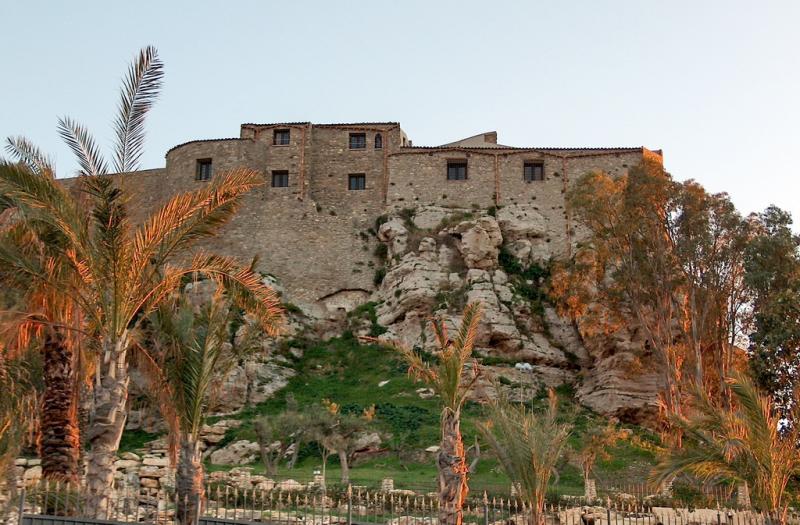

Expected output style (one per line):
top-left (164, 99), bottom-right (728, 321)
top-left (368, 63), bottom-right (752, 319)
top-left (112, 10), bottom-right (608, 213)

top-left (120, 122), bottom-right (661, 314)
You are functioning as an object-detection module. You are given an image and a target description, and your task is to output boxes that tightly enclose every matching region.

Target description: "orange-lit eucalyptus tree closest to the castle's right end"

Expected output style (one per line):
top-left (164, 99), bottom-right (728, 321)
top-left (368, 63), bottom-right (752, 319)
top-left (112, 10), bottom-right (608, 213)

top-left (552, 162), bottom-right (687, 440)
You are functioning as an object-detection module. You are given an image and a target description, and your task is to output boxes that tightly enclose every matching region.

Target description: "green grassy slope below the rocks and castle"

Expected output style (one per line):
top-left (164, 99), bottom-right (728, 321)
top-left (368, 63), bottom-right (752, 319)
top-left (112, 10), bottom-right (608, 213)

top-left (122, 337), bottom-right (653, 495)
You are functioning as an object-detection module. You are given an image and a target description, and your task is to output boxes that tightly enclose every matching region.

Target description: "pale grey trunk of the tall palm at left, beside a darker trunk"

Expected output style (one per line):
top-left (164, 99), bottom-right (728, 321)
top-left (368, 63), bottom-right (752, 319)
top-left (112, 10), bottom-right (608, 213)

top-left (86, 337), bottom-right (129, 519)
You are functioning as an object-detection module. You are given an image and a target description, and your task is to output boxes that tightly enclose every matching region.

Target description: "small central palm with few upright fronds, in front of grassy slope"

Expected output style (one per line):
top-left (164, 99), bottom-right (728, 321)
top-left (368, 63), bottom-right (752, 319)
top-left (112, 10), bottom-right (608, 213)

top-left (386, 303), bottom-right (481, 525)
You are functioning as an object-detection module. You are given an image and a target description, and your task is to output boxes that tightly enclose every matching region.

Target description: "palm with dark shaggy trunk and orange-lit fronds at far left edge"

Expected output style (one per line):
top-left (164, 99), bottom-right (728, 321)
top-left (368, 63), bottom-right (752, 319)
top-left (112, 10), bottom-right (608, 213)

top-left (0, 145), bottom-right (81, 483)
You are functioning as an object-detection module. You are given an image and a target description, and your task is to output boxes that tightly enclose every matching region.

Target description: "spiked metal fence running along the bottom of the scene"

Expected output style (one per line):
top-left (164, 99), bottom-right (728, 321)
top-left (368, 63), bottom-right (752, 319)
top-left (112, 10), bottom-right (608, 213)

top-left (7, 483), bottom-right (800, 525)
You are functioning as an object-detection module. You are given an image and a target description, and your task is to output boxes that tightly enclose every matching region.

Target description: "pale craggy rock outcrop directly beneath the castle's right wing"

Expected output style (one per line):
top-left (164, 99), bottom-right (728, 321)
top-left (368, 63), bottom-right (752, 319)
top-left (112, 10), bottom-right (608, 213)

top-left (371, 204), bottom-right (658, 422)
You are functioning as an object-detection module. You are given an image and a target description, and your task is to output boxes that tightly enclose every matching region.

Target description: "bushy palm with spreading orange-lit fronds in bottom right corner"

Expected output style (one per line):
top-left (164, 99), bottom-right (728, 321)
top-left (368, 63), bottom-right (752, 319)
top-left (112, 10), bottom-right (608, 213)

top-left (652, 375), bottom-right (800, 523)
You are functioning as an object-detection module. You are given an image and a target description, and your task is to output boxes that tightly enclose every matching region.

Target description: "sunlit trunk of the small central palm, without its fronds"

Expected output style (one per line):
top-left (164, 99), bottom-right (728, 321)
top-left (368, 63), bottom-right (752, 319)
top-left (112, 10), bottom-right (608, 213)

top-left (438, 408), bottom-right (469, 525)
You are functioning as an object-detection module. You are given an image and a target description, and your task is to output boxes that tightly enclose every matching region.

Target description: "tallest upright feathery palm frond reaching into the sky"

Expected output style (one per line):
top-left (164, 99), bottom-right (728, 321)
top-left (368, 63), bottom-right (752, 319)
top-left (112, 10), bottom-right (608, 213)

top-left (114, 46), bottom-right (164, 173)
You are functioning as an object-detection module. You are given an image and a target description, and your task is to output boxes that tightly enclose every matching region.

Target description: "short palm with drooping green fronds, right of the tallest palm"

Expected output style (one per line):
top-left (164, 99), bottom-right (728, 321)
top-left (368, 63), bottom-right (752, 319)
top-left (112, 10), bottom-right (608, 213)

top-left (138, 288), bottom-right (281, 524)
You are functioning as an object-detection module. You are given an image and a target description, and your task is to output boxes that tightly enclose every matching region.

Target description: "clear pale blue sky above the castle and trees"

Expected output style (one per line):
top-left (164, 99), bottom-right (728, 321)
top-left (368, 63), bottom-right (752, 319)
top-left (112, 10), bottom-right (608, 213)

top-left (0, 0), bottom-right (800, 226)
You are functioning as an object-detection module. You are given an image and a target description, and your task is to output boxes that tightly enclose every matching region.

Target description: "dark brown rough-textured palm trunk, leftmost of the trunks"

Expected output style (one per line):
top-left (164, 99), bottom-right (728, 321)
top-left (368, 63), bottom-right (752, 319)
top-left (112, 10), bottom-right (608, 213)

top-left (39, 328), bottom-right (80, 484)
